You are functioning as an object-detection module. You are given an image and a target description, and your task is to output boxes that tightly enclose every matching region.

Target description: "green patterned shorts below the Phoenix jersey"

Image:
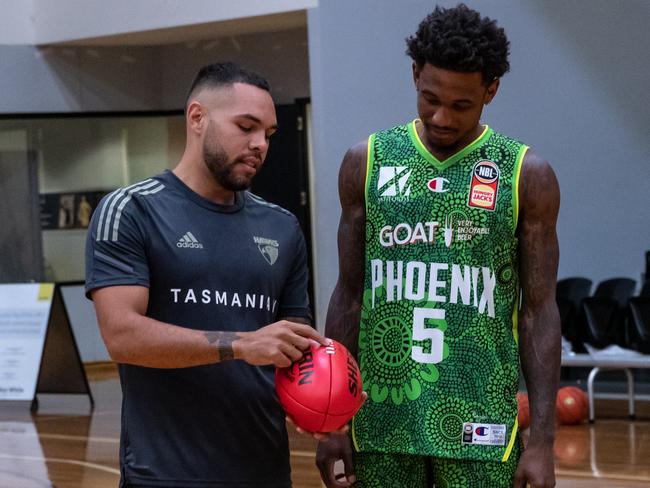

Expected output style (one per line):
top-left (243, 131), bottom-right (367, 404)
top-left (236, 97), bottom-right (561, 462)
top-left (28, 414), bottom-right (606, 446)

top-left (354, 438), bottom-right (521, 488)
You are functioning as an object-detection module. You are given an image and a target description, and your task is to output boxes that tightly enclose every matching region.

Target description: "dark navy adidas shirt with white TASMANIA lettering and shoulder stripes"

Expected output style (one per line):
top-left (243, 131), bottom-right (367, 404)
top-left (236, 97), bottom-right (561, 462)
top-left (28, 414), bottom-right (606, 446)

top-left (86, 171), bottom-right (309, 488)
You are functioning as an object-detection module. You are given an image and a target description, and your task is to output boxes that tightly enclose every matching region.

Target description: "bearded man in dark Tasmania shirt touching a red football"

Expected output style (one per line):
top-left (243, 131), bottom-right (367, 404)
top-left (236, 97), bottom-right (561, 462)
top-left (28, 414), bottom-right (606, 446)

top-left (86, 63), bottom-right (328, 488)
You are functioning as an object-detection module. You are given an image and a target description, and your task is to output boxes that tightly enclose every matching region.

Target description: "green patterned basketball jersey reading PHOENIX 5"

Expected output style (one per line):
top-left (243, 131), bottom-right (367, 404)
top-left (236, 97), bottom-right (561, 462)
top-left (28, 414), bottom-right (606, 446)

top-left (352, 122), bottom-right (527, 461)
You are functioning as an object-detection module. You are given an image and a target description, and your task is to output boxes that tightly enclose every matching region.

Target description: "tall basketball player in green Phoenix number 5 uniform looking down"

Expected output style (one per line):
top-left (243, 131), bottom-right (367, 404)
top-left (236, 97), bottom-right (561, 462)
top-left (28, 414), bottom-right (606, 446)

top-left (317, 4), bottom-right (560, 488)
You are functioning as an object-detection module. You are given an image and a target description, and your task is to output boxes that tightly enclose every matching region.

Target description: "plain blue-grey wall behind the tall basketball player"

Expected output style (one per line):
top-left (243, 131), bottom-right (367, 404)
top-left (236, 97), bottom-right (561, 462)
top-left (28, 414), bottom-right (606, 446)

top-left (308, 0), bottom-right (650, 326)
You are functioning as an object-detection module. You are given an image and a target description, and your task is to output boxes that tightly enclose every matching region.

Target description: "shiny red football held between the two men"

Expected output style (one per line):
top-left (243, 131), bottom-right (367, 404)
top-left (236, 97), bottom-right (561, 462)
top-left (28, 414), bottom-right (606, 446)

top-left (275, 341), bottom-right (363, 432)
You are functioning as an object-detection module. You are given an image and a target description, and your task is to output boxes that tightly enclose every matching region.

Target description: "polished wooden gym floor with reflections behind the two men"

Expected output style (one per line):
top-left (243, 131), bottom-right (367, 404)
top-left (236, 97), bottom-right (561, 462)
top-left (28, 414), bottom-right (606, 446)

top-left (0, 365), bottom-right (650, 488)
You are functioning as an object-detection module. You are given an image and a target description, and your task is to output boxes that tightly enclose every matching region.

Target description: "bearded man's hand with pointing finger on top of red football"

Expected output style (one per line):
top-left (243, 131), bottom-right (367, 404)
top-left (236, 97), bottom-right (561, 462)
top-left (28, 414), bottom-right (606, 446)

top-left (232, 320), bottom-right (330, 368)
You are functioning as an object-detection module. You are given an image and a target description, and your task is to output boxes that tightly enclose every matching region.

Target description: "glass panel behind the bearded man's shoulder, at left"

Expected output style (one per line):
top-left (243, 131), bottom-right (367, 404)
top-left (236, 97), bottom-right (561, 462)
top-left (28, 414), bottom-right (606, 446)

top-left (0, 114), bottom-right (185, 281)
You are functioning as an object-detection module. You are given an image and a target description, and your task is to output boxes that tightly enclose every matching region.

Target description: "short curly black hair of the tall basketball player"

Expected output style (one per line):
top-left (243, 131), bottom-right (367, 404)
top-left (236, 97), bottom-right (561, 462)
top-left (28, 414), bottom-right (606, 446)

top-left (406, 3), bottom-right (510, 85)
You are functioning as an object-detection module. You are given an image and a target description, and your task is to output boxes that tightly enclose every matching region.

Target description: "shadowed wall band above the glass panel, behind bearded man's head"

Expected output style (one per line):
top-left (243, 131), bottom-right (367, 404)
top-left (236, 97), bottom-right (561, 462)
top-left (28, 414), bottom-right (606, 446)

top-left (0, 28), bottom-right (309, 113)
